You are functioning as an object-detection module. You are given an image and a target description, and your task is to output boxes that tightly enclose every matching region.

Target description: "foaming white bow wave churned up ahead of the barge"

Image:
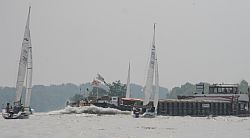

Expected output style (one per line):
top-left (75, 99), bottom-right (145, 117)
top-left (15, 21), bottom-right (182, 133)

top-left (48, 105), bottom-right (131, 115)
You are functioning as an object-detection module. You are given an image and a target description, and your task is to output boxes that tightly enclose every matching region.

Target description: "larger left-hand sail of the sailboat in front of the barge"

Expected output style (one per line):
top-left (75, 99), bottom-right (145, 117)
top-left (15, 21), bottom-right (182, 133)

top-left (143, 24), bottom-right (155, 105)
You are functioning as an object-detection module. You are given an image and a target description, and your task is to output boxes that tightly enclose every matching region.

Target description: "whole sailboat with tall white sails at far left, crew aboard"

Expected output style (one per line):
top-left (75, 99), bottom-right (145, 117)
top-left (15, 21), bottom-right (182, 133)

top-left (2, 7), bottom-right (33, 119)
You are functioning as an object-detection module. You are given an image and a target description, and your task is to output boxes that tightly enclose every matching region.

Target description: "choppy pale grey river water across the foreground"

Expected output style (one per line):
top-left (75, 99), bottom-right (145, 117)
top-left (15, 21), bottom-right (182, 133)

top-left (0, 107), bottom-right (250, 138)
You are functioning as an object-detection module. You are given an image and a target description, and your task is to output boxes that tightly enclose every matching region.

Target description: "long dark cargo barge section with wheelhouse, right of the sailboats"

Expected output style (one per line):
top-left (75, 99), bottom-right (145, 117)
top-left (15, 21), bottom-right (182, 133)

top-left (158, 84), bottom-right (250, 116)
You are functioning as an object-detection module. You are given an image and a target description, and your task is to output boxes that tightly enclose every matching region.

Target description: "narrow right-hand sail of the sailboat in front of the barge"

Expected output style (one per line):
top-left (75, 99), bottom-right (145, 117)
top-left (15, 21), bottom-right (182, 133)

top-left (154, 54), bottom-right (159, 112)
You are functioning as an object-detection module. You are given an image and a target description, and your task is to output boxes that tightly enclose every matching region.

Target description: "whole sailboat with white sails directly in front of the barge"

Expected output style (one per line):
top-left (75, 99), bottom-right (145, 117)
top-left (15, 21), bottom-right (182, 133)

top-left (133, 24), bottom-right (159, 118)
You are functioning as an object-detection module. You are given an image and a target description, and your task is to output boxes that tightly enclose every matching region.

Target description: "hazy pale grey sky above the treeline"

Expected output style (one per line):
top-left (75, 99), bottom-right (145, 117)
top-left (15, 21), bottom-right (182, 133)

top-left (0, 0), bottom-right (250, 88)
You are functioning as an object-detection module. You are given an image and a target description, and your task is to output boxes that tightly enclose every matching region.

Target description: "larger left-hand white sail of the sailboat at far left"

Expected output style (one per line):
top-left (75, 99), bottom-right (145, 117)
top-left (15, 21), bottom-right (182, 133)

top-left (16, 5), bottom-right (31, 102)
